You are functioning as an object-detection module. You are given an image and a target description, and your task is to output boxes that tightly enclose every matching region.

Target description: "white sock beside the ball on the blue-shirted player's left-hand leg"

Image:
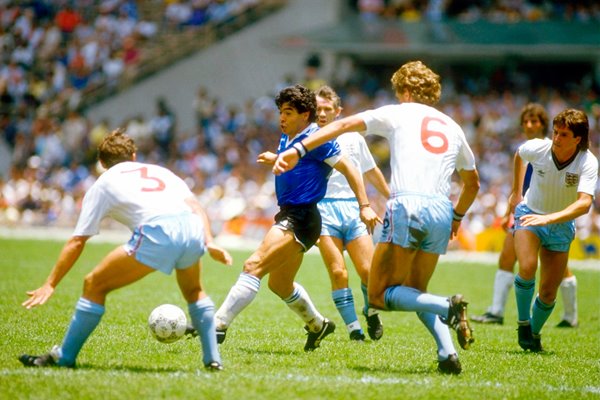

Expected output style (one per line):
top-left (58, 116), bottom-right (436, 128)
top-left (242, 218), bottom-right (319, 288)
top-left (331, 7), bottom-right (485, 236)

top-left (215, 272), bottom-right (260, 329)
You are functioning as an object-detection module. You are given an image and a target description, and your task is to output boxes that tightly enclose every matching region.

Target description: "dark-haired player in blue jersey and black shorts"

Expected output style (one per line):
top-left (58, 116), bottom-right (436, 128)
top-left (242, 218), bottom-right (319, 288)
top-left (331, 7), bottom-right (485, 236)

top-left (215, 85), bottom-right (381, 351)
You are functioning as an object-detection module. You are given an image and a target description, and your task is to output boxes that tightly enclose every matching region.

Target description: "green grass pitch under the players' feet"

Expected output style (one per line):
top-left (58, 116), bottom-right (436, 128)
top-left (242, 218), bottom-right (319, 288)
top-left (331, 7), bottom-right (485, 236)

top-left (0, 239), bottom-right (600, 399)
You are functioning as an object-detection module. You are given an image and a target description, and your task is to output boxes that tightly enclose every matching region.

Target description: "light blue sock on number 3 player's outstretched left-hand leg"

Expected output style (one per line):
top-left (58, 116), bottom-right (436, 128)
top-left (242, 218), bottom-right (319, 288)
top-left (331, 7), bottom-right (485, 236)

top-left (58, 297), bottom-right (104, 367)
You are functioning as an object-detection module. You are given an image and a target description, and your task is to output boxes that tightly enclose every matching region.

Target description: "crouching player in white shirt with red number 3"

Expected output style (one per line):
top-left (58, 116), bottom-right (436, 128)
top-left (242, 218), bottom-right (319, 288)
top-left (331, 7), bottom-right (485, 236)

top-left (19, 129), bottom-right (232, 371)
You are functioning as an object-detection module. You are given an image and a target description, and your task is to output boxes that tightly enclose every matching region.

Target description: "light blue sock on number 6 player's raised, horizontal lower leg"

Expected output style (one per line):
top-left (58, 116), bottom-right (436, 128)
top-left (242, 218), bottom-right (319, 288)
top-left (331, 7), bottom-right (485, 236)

top-left (384, 286), bottom-right (450, 318)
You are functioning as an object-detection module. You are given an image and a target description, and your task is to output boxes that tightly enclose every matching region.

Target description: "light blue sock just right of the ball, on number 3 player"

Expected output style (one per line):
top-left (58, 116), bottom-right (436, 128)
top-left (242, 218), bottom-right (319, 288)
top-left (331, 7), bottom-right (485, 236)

top-left (188, 297), bottom-right (221, 366)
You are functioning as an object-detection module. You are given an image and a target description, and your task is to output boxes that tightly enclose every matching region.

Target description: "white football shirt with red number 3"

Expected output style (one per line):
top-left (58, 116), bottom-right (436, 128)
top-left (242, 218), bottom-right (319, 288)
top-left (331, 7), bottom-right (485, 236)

top-left (73, 162), bottom-right (193, 236)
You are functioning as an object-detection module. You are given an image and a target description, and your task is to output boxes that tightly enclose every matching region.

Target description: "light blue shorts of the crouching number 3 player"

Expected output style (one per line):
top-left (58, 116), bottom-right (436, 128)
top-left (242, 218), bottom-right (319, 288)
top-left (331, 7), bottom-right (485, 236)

top-left (123, 213), bottom-right (206, 275)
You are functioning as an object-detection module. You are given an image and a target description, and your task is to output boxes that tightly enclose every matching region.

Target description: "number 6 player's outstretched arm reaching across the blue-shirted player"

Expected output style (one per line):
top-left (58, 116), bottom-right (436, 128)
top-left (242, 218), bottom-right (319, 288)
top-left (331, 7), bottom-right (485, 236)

top-left (273, 115), bottom-right (367, 175)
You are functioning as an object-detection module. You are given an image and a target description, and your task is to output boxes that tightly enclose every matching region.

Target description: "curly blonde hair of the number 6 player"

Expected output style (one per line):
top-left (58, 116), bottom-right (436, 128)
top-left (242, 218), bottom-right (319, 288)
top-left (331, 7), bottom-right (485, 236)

top-left (391, 61), bottom-right (442, 106)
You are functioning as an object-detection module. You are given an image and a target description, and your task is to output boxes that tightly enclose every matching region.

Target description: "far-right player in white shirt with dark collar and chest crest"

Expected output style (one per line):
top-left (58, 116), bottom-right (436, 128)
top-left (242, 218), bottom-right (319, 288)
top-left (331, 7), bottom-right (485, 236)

top-left (509, 109), bottom-right (598, 352)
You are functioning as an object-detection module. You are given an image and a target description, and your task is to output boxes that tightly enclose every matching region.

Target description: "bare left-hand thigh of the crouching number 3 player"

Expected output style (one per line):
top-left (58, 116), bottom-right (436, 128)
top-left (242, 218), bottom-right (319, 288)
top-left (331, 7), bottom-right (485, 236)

top-left (84, 246), bottom-right (156, 304)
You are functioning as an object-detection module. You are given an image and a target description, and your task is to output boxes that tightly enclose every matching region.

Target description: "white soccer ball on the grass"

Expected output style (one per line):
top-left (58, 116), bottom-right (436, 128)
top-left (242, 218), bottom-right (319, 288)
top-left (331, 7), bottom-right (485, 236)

top-left (148, 304), bottom-right (187, 343)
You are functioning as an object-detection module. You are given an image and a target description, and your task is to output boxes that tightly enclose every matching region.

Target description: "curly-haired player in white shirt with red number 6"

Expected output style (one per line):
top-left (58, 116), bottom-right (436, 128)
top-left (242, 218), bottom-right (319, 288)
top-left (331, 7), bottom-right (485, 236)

top-left (273, 61), bottom-right (479, 374)
